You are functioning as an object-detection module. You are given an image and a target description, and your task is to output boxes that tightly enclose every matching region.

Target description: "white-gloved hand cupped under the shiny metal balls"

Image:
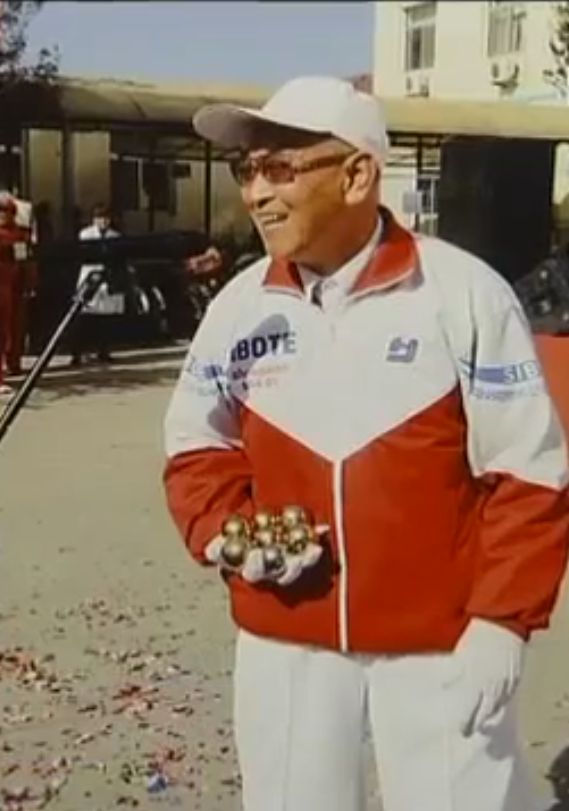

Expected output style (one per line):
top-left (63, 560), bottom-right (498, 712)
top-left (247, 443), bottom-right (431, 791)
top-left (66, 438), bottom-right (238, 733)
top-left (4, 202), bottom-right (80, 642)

top-left (205, 524), bottom-right (330, 586)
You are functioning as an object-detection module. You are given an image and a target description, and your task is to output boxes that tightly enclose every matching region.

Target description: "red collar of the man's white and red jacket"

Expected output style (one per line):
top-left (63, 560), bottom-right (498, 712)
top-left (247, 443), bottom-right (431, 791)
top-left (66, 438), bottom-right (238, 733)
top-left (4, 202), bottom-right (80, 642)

top-left (263, 206), bottom-right (419, 296)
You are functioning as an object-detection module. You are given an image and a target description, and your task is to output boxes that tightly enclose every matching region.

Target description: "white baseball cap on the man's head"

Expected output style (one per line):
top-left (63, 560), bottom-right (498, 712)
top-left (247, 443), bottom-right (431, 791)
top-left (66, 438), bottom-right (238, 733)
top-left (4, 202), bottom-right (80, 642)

top-left (193, 76), bottom-right (389, 164)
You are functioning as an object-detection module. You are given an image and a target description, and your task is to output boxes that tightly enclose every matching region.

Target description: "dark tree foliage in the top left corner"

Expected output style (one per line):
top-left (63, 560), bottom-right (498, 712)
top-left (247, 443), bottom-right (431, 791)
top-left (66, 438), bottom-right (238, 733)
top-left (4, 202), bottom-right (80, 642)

top-left (0, 0), bottom-right (59, 88)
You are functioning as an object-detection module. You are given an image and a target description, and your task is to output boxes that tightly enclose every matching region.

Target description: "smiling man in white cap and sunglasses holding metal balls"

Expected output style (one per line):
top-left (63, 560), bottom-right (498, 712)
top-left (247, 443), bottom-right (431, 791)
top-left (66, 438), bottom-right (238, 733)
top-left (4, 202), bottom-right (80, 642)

top-left (161, 77), bottom-right (568, 811)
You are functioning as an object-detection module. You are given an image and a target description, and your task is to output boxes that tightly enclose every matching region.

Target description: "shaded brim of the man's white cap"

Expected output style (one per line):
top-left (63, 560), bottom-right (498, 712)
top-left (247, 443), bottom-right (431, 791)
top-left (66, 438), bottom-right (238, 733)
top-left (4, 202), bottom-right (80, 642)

top-left (192, 104), bottom-right (330, 149)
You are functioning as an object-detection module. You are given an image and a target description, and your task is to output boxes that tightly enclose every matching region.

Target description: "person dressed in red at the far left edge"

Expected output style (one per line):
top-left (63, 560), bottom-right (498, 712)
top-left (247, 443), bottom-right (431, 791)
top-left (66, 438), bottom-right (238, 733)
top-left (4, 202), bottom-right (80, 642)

top-left (0, 193), bottom-right (28, 394)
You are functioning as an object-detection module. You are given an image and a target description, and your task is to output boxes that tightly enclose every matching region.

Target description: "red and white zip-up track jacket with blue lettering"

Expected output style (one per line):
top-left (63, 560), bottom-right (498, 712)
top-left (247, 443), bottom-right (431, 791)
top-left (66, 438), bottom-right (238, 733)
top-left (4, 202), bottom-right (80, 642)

top-left (161, 210), bottom-right (569, 653)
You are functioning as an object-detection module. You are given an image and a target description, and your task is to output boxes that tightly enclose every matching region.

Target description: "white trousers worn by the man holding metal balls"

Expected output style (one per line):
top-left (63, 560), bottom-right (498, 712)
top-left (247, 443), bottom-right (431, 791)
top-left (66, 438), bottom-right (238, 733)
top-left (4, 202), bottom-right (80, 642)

top-left (235, 631), bottom-right (543, 811)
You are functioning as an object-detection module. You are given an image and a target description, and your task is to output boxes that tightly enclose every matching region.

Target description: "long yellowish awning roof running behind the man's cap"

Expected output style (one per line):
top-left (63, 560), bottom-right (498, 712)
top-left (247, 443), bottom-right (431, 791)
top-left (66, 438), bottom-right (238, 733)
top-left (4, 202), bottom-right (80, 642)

top-left (0, 78), bottom-right (569, 141)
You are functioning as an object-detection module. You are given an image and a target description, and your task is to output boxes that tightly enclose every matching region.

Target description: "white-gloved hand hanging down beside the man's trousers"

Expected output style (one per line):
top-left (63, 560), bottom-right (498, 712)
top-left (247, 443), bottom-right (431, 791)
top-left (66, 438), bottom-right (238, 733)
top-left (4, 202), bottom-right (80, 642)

top-left (454, 618), bottom-right (525, 737)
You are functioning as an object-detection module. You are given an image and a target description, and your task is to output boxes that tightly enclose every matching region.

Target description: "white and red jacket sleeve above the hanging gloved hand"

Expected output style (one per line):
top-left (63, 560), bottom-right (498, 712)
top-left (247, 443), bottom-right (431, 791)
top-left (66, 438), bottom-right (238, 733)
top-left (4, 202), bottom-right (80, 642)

top-left (461, 274), bottom-right (569, 638)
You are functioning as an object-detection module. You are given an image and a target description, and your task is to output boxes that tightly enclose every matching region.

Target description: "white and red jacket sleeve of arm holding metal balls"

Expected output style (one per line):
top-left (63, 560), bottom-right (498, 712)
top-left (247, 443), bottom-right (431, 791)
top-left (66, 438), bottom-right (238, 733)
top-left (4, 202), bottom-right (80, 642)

top-left (164, 302), bottom-right (252, 564)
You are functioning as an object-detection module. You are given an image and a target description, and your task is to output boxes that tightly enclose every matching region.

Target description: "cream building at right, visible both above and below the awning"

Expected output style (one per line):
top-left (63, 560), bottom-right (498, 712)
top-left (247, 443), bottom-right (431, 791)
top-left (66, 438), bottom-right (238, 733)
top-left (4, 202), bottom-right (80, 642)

top-left (373, 0), bottom-right (569, 235)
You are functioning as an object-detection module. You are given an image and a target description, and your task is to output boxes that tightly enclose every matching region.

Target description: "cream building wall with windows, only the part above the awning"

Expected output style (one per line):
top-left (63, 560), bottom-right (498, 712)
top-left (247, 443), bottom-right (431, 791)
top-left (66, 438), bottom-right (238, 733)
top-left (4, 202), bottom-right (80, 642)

top-left (374, 0), bottom-right (563, 104)
